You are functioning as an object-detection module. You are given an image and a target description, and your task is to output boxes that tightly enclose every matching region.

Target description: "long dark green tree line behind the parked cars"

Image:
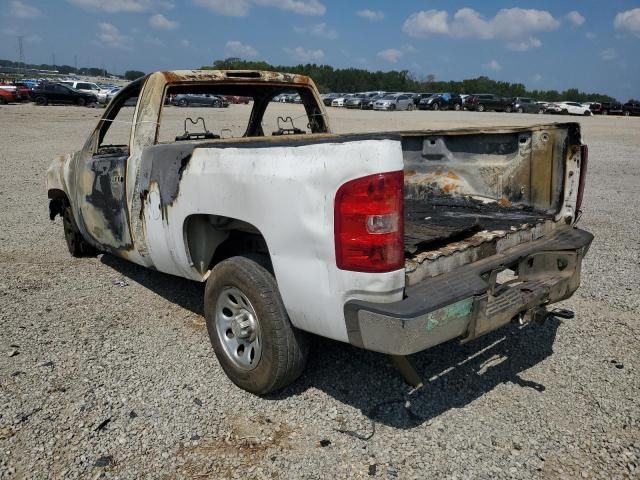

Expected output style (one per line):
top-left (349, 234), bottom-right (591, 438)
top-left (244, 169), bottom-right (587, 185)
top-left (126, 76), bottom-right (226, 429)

top-left (201, 58), bottom-right (616, 102)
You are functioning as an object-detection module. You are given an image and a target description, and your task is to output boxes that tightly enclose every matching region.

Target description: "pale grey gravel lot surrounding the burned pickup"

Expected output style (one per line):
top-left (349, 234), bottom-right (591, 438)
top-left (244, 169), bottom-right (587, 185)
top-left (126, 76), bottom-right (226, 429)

top-left (0, 105), bottom-right (640, 479)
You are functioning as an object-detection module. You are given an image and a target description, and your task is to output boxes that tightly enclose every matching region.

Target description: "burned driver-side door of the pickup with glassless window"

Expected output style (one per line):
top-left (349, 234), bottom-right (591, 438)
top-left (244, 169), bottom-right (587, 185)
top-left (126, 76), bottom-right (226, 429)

top-left (76, 90), bottom-right (135, 253)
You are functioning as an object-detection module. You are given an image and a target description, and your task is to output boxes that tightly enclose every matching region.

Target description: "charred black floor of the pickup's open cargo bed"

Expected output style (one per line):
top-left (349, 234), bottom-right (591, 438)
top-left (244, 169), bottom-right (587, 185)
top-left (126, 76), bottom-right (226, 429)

top-left (404, 193), bottom-right (554, 254)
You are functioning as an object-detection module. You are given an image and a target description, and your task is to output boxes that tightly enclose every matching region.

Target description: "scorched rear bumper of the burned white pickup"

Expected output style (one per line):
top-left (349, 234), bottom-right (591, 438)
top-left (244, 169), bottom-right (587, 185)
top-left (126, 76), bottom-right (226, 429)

top-left (344, 228), bottom-right (593, 355)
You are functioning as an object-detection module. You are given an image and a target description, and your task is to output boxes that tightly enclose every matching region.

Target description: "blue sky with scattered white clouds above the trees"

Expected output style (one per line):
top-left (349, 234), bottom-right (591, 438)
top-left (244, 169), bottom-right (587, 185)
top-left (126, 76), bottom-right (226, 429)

top-left (0, 0), bottom-right (640, 101)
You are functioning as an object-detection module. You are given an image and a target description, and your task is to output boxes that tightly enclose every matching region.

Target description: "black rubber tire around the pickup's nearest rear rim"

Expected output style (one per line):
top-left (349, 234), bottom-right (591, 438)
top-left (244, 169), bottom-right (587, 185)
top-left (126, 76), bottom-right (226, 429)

top-left (204, 257), bottom-right (309, 395)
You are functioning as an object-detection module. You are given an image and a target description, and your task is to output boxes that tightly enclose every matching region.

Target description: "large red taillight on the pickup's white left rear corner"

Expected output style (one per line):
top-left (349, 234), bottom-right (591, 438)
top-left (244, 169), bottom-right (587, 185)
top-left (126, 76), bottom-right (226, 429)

top-left (334, 171), bottom-right (404, 272)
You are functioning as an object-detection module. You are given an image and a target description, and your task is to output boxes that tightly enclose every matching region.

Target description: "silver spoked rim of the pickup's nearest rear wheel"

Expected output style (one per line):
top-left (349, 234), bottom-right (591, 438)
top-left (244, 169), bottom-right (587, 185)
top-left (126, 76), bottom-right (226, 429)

top-left (216, 287), bottom-right (262, 370)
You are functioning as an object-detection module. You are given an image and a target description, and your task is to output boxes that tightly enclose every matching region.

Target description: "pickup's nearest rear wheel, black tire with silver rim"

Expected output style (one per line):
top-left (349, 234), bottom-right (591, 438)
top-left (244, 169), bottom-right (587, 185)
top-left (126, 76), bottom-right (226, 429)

top-left (204, 257), bottom-right (309, 395)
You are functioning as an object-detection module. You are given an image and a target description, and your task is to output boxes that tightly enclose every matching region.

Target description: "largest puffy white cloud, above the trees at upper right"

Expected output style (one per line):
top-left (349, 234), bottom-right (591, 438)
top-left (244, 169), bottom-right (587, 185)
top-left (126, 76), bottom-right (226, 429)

top-left (402, 8), bottom-right (560, 40)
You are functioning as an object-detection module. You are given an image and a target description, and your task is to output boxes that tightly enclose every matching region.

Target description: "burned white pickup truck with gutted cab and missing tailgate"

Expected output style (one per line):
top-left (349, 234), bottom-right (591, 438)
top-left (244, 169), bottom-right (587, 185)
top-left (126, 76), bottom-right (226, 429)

top-left (47, 70), bottom-right (593, 394)
